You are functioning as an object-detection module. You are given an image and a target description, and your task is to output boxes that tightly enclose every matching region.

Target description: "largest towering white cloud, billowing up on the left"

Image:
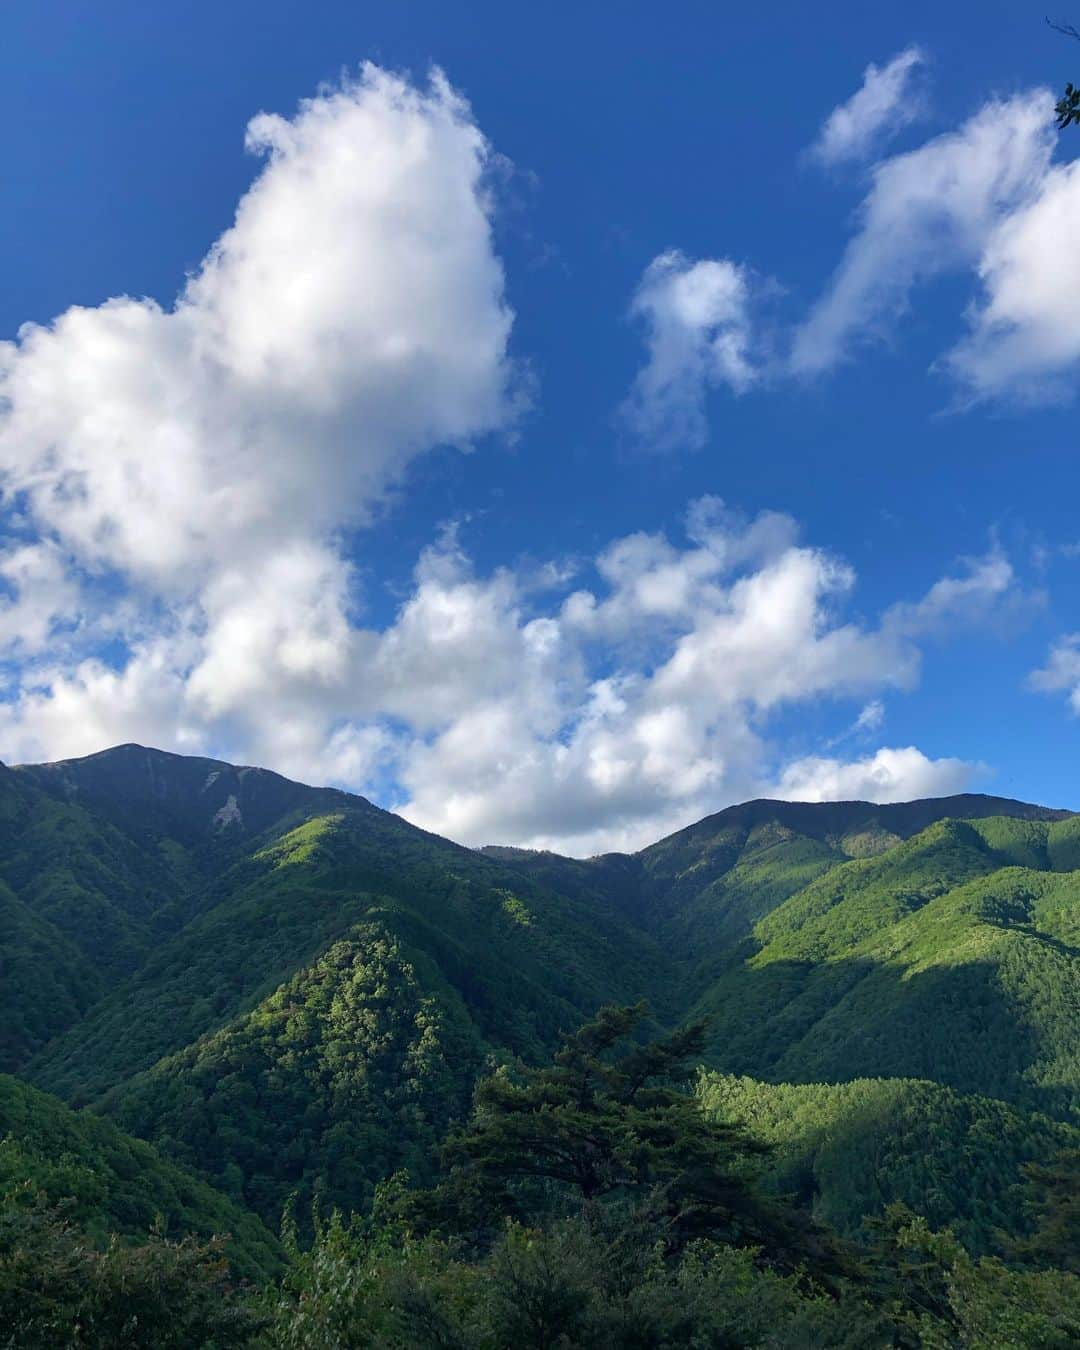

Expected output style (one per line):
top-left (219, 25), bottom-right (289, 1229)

top-left (0, 65), bottom-right (516, 763)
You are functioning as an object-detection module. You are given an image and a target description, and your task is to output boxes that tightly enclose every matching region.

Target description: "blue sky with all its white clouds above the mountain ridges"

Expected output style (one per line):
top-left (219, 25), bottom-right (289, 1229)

top-left (0, 0), bottom-right (1080, 853)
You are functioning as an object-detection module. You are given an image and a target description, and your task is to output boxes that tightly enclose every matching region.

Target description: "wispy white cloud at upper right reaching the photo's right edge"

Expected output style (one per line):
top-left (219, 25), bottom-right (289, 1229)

top-left (790, 72), bottom-right (1080, 404)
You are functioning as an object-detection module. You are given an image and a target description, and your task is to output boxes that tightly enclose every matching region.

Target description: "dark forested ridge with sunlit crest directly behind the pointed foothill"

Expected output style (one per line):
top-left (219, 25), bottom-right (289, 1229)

top-left (26, 803), bottom-right (671, 1102)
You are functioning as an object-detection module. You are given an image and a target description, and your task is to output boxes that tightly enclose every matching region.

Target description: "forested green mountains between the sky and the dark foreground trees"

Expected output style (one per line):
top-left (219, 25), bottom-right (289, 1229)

top-left (0, 747), bottom-right (1080, 1344)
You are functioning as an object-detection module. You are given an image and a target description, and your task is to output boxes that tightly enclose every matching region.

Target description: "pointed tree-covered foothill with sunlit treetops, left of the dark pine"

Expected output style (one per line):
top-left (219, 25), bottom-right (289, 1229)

top-left (103, 922), bottom-right (482, 1223)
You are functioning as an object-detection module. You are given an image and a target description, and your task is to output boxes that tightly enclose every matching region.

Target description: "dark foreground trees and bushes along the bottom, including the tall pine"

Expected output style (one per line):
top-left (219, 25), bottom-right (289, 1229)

top-left (14, 1007), bottom-right (1080, 1350)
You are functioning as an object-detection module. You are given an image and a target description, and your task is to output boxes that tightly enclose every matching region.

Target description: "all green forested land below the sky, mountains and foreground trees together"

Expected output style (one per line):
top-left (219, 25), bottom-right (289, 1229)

top-left (0, 745), bottom-right (1080, 1350)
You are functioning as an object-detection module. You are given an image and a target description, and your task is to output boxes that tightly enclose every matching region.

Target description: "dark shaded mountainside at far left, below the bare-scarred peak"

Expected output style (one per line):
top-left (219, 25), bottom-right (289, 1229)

top-left (0, 745), bottom-right (375, 1069)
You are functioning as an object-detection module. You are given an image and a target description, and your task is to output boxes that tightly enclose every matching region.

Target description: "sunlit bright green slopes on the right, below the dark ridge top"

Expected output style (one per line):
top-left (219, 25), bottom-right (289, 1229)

top-left (699, 819), bottom-right (1080, 1118)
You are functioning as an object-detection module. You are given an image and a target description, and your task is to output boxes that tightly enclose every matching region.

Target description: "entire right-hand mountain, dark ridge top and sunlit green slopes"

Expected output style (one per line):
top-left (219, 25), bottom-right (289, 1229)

top-left (486, 795), bottom-right (1080, 1119)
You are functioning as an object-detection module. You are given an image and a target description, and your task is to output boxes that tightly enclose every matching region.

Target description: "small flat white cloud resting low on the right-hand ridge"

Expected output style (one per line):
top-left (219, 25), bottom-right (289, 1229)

top-left (774, 745), bottom-right (987, 802)
